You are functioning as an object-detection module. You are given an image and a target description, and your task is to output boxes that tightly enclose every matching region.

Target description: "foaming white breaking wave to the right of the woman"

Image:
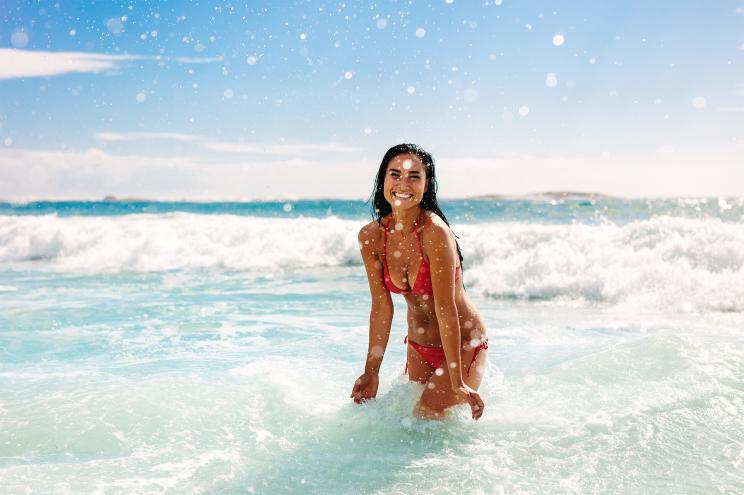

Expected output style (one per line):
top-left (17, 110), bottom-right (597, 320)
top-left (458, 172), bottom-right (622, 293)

top-left (458, 217), bottom-right (744, 312)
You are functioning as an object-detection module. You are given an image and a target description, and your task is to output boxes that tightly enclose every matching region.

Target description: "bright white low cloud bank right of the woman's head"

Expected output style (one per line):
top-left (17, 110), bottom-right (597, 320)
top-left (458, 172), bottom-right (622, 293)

top-left (437, 150), bottom-right (744, 198)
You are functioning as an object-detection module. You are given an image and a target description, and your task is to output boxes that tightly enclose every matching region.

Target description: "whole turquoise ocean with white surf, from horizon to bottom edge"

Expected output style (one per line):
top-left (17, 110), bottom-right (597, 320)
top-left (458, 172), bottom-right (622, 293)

top-left (0, 197), bottom-right (744, 495)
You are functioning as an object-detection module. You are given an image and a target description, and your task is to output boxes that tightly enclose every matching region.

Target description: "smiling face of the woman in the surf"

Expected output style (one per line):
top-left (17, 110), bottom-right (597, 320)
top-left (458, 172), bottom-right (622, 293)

top-left (383, 153), bottom-right (428, 209)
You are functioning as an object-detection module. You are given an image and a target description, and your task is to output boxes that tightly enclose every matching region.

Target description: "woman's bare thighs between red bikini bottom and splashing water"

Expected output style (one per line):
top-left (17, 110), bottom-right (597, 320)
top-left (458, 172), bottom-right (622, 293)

top-left (414, 346), bottom-right (488, 418)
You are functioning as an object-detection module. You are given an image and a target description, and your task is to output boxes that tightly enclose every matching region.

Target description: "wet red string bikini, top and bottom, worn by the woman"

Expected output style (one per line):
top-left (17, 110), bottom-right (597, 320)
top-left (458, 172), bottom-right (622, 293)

top-left (382, 218), bottom-right (488, 376)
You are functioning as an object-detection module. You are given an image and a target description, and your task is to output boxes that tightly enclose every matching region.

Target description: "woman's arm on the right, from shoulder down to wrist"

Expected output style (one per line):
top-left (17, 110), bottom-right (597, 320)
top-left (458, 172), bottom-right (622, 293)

top-left (424, 223), bottom-right (465, 389)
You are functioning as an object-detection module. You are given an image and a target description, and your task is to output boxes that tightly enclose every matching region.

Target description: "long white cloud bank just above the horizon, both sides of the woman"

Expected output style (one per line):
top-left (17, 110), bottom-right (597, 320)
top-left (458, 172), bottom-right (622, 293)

top-left (0, 146), bottom-right (744, 201)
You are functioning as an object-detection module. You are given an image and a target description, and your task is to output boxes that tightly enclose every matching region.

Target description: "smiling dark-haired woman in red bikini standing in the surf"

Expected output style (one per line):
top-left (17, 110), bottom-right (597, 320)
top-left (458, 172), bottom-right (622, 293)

top-left (351, 144), bottom-right (488, 420)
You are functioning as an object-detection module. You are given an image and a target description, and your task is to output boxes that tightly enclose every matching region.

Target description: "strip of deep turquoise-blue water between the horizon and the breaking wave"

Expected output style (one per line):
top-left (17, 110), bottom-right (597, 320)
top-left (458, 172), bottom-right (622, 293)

top-left (0, 198), bottom-right (744, 223)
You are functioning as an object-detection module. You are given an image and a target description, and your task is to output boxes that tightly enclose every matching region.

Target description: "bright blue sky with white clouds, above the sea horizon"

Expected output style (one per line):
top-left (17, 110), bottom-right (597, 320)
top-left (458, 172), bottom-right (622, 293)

top-left (0, 0), bottom-right (744, 201)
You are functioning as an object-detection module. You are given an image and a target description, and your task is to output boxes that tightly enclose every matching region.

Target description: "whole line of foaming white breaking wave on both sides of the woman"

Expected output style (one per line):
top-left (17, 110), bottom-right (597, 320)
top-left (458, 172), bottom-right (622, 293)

top-left (0, 213), bottom-right (744, 313)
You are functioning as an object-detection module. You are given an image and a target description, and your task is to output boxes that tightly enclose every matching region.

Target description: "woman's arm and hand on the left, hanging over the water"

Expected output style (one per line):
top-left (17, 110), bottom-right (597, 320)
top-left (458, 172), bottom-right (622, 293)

top-left (351, 222), bottom-right (394, 402)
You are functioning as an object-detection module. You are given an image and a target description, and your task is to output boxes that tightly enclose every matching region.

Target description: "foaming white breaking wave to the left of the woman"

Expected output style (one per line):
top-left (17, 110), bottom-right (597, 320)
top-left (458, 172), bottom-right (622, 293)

top-left (0, 213), bottom-right (359, 273)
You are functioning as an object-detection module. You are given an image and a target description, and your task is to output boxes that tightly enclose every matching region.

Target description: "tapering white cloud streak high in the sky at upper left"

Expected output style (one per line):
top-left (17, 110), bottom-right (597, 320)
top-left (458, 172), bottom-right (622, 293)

top-left (0, 48), bottom-right (222, 80)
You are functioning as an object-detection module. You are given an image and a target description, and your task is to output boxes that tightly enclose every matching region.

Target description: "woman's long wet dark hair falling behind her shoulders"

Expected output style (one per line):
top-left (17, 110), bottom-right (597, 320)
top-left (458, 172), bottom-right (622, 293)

top-left (367, 144), bottom-right (463, 266)
